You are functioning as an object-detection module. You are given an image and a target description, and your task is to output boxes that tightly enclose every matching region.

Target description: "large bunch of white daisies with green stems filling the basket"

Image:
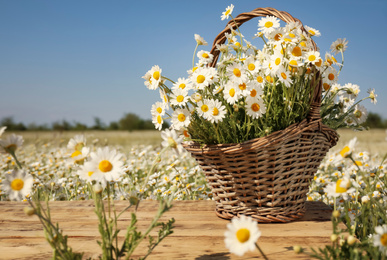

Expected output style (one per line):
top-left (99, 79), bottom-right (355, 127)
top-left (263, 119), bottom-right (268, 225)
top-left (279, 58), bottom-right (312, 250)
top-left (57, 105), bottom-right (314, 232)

top-left (143, 5), bottom-right (376, 144)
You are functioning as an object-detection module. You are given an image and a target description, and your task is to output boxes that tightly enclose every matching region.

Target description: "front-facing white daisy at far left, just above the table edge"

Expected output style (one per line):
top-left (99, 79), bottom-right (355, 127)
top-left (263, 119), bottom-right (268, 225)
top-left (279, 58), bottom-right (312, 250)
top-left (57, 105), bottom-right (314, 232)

top-left (2, 169), bottom-right (34, 200)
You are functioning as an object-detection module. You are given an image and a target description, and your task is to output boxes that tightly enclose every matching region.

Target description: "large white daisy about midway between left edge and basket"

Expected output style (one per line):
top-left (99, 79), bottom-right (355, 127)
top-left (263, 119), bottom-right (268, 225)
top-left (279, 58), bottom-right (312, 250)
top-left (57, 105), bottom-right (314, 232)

top-left (84, 147), bottom-right (124, 183)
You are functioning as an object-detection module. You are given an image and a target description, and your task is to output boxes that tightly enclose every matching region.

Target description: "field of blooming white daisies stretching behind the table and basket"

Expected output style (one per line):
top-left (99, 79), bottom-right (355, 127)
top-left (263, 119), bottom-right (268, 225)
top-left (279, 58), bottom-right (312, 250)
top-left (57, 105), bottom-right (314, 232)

top-left (0, 127), bottom-right (387, 259)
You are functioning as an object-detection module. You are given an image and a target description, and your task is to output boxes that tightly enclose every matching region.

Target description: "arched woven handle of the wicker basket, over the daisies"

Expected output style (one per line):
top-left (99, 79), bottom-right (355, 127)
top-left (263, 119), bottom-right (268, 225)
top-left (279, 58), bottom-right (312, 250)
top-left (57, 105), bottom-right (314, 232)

top-left (209, 7), bottom-right (322, 111)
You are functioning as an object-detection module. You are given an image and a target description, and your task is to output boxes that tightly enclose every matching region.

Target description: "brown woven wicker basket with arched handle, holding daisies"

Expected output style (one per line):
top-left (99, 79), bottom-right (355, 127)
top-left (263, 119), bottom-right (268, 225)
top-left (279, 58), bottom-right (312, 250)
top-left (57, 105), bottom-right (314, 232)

top-left (183, 8), bottom-right (338, 222)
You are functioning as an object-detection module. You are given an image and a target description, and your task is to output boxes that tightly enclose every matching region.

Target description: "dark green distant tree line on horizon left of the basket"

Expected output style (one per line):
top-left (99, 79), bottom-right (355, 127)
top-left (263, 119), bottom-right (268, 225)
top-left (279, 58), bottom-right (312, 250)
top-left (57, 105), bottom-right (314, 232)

top-left (0, 113), bottom-right (169, 131)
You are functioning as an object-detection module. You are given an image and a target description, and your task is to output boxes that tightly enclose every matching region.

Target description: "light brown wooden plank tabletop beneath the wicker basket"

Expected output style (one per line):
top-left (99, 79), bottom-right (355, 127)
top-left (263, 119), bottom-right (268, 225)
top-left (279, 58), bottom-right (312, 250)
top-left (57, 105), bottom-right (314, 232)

top-left (0, 201), bottom-right (332, 260)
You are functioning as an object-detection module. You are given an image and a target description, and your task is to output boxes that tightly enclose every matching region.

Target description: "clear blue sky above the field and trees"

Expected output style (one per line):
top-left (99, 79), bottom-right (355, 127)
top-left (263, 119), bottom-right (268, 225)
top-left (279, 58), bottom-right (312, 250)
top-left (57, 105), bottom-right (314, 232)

top-left (0, 0), bottom-right (387, 125)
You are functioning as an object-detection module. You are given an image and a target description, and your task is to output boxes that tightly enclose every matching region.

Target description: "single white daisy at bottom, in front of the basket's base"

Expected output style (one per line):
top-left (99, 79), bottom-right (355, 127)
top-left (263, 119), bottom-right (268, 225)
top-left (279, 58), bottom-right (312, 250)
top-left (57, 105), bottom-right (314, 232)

top-left (224, 216), bottom-right (261, 256)
